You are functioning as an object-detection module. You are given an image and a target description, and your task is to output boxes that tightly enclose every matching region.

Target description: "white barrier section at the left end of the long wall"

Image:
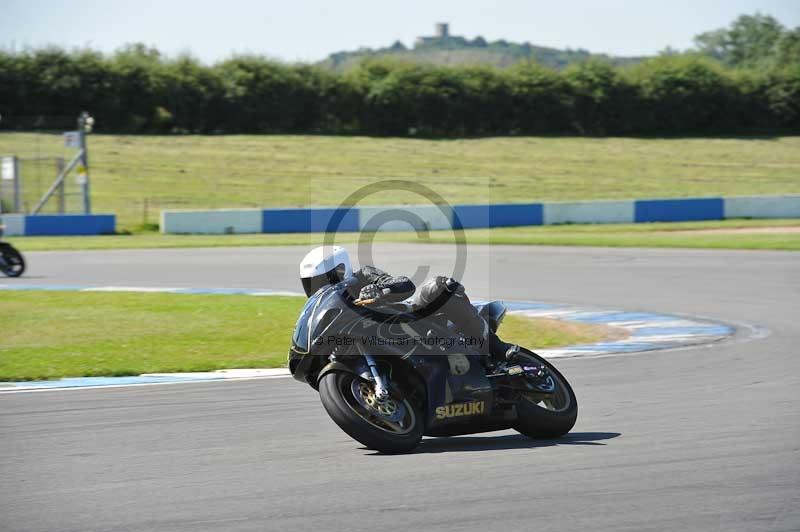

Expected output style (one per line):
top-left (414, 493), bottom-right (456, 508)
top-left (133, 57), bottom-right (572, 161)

top-left (161, 209), bottom-right (263, 235)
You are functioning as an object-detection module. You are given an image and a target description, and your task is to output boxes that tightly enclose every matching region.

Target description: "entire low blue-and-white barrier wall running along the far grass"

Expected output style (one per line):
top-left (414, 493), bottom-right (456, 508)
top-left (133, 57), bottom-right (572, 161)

top-left (10, 195), bottom-right (800, 236)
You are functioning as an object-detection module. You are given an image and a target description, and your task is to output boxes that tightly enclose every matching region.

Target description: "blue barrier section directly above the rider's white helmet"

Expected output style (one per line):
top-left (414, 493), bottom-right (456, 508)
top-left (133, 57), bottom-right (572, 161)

top-left (262, 208), bottom-right (358, 233)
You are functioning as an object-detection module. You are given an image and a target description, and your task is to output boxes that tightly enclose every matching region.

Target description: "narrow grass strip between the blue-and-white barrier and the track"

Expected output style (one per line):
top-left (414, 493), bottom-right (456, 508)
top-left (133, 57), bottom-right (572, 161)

top-left (9, 220), bottom-right (800, 252)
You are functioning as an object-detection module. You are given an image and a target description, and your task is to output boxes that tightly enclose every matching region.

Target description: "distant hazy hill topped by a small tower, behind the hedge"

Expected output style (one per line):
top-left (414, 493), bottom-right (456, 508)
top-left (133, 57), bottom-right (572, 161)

top-left (320, 24), bottom-right (645, 71)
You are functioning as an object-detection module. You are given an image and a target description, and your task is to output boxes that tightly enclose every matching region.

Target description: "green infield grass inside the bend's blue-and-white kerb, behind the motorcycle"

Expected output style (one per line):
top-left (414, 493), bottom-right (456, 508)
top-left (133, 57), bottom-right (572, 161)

top-left (0, 292), bottom-right (607, 380)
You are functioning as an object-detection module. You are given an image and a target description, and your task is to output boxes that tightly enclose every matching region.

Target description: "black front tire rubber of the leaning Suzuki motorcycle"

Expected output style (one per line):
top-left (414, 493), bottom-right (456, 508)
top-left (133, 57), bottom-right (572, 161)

top-left (319, 371), bottom-right (425, 454)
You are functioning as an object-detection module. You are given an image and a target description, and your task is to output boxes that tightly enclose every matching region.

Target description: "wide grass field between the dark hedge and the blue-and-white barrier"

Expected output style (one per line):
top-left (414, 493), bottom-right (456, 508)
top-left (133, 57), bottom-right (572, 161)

top-left (0, 133), bottom-right (800, 229)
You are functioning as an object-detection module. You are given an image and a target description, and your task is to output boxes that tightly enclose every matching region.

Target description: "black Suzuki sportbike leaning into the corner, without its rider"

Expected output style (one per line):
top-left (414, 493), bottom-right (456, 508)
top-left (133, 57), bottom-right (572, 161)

top-left (289, 280), bottom-right (578, 453)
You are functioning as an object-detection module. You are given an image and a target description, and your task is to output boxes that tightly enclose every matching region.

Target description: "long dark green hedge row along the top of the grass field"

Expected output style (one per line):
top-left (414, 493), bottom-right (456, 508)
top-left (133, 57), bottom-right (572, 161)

top-left (0, 45), bottom-right (800, 136)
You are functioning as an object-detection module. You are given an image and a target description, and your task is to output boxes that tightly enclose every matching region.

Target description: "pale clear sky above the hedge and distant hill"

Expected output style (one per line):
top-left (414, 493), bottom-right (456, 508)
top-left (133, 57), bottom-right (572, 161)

top-left (0, 0), bottom-right (800, 63)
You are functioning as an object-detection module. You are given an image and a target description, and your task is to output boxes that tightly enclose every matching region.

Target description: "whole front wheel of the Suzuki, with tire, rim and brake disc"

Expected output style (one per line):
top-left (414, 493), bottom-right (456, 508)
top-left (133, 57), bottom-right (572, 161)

top-left (319, 371), bottom-right (425, 454)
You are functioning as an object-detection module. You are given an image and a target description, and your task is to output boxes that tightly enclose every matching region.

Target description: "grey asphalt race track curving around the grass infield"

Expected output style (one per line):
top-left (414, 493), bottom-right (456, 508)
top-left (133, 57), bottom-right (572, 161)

top-left (0, 245), bottom-right (800, 532)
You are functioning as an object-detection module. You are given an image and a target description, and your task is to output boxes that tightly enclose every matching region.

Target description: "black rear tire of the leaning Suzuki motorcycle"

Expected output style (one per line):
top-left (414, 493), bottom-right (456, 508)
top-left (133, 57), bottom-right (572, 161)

top-left (514, 350), bottom-right (578, 438)
